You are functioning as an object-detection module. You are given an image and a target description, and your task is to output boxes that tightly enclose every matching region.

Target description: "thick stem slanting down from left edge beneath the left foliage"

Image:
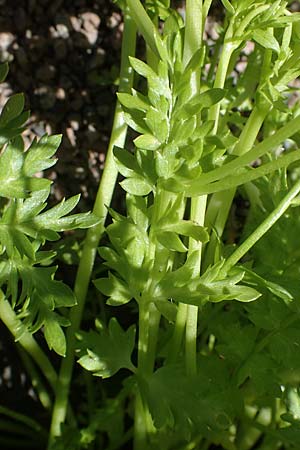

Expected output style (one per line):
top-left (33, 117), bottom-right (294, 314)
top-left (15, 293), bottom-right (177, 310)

top-left (0, 290), bottom-right (57, 391)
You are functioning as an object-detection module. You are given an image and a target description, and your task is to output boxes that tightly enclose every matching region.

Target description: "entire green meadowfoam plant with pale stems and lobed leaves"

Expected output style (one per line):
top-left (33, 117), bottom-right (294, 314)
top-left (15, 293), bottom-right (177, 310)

top-left (0, 0), bottom-right (300, 450)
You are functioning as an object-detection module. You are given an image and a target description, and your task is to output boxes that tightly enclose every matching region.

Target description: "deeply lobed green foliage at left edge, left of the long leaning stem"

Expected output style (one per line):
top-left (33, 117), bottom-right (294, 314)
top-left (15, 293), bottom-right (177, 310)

top-left (0, 66), bottom-right (98, 356)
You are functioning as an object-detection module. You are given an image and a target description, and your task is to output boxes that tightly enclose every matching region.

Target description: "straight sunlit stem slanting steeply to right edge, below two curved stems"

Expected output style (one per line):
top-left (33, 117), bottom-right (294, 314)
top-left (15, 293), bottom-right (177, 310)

top-left (220, 181), bottom-right (300, 277)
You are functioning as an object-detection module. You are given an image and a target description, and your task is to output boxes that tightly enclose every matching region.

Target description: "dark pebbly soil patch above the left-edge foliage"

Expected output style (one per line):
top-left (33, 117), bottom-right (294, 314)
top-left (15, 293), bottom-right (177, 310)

top-left (0, 0), bottom-right (122, 209)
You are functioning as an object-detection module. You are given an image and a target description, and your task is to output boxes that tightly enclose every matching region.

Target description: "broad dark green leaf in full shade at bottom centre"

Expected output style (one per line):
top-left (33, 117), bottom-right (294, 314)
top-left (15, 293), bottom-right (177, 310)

top-left (138, 357), bottom-right (241, 440)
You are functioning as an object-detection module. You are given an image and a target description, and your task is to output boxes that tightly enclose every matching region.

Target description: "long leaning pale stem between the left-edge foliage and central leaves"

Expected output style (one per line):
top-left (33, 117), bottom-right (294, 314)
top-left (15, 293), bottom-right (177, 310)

top-left (48, 12), bottom-right (136, 442)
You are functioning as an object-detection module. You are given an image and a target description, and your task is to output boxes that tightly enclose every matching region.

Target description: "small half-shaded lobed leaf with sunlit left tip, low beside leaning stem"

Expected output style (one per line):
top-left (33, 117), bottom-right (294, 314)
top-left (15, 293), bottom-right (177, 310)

top-left (78, 318), bottom-right (135, 378)
